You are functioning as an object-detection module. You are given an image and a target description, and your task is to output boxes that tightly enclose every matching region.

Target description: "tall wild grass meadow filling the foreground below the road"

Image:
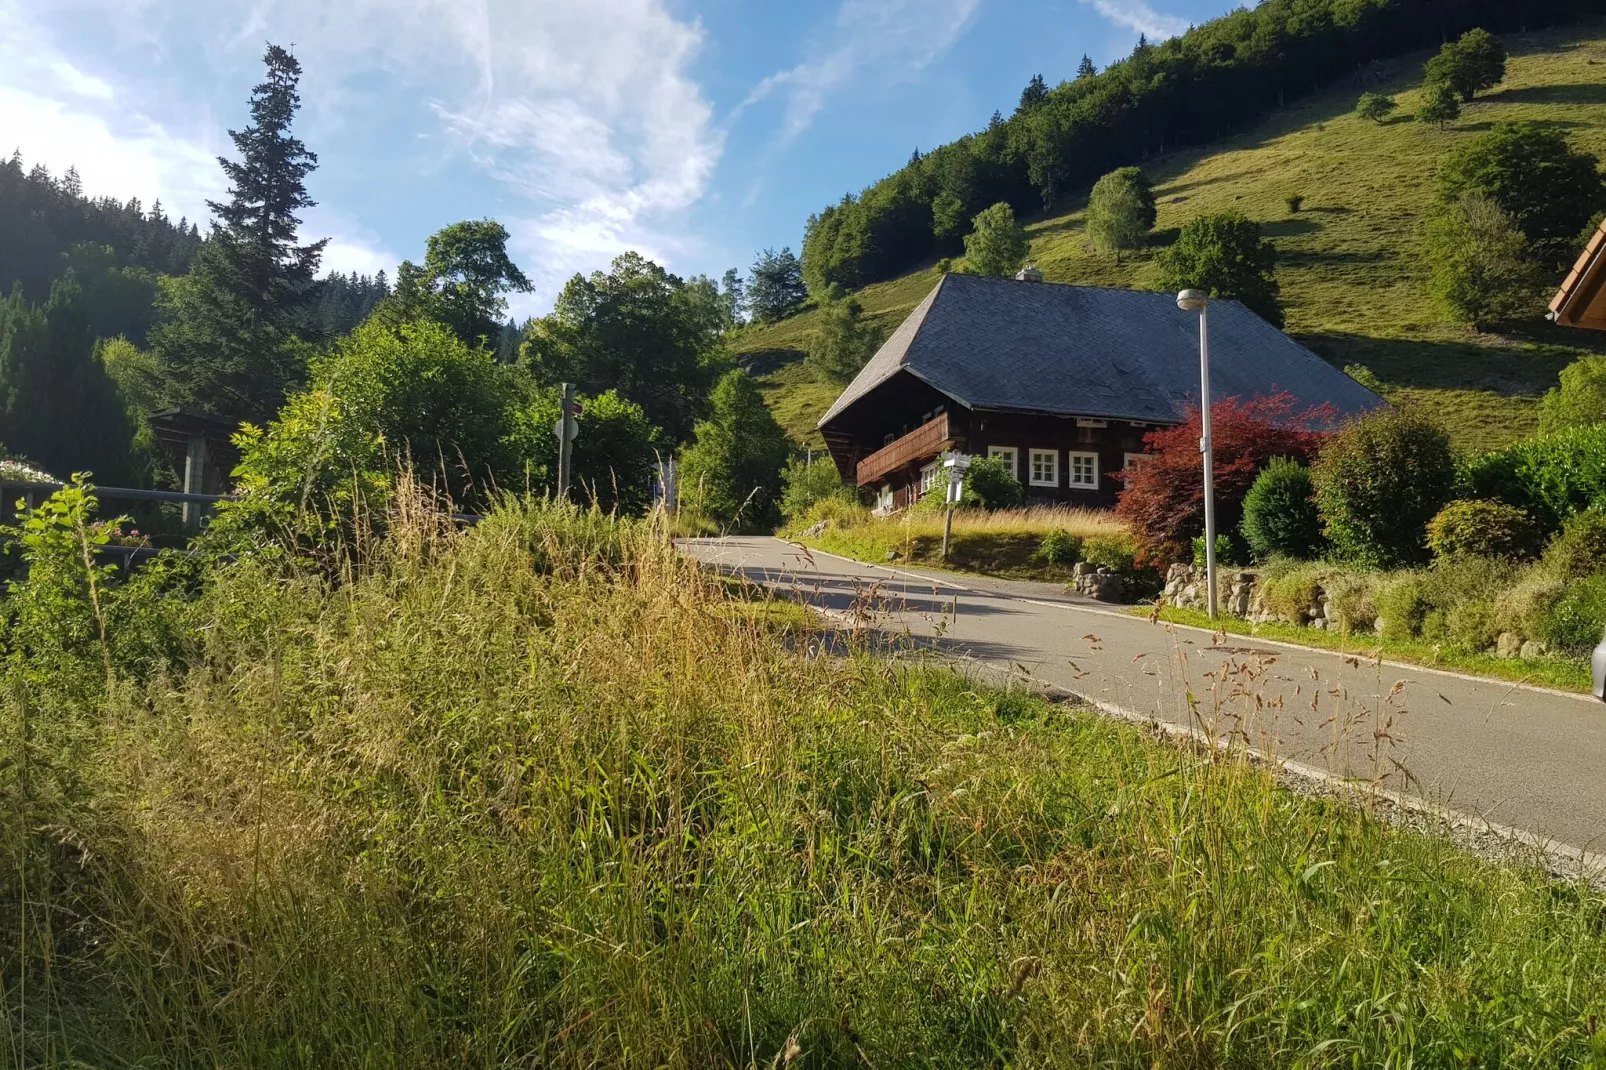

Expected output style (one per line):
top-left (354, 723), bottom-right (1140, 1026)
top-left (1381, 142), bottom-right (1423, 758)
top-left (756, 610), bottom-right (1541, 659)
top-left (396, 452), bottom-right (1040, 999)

top-left (9, 488), bottom-right (1606, 1068)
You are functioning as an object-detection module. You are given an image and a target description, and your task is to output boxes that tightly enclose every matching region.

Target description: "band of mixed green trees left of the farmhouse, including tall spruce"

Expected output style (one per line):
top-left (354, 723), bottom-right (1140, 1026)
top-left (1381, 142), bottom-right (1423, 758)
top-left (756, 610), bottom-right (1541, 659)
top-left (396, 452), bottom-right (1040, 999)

top-left (0, 45), bottom-right (805, 530)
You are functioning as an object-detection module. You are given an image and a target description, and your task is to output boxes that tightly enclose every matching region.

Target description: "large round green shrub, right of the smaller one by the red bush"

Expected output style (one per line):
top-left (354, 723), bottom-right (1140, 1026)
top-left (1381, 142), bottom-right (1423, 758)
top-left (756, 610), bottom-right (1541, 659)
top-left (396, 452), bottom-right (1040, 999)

top-left (1310, 410), bottom-right (1457, 567)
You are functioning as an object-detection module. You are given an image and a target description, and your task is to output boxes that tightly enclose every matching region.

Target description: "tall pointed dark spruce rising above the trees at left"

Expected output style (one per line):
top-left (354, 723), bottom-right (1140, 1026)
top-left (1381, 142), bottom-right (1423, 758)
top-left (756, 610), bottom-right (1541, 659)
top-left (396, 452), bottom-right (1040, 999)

top-left (151, 45), bottom-right (328, 421)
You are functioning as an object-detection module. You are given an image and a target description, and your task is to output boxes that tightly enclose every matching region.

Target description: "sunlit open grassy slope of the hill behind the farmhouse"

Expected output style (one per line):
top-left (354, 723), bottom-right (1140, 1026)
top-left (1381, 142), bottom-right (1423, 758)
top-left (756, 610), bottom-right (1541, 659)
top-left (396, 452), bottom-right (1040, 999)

top-left (737, 19), bottom-right (1606, 448)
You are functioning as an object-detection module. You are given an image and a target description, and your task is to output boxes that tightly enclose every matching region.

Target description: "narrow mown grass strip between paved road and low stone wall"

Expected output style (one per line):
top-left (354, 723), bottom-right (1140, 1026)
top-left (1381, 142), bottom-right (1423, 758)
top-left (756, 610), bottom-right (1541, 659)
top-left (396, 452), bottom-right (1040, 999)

top-left (1156, 606), bottom-right (1593, 694)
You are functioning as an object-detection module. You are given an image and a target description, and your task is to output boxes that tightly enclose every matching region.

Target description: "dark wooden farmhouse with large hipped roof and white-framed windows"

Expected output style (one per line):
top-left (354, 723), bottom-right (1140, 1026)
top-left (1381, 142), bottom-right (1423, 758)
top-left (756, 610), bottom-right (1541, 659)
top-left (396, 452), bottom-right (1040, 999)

top-left (819, 268), bottom-right (1384, 511)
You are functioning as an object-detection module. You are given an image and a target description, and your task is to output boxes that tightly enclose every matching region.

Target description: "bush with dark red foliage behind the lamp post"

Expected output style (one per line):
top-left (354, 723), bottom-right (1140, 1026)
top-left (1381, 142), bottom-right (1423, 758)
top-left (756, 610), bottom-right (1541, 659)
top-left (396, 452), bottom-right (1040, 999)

top-left (1115, 392), bottom-right (1336, 566)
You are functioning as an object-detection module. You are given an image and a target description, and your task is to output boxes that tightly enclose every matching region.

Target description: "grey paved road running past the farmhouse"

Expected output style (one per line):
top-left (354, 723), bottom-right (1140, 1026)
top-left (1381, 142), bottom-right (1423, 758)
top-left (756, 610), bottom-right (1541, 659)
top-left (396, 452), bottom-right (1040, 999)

top-left (684, 537), bottom-right (1606, 853)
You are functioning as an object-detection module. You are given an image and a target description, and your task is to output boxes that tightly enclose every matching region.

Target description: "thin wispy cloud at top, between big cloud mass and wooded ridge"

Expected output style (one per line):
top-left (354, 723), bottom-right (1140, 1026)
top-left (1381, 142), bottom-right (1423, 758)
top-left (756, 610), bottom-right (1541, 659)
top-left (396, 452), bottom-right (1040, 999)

top-left (745, 0), bottom-right (980, 143)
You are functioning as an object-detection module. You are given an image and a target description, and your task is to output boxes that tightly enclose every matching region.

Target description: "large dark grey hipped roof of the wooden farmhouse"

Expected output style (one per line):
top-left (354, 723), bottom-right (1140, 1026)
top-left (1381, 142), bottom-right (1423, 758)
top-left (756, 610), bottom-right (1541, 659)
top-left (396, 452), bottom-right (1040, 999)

top-left (819, 275), bottom-right (1384, 427)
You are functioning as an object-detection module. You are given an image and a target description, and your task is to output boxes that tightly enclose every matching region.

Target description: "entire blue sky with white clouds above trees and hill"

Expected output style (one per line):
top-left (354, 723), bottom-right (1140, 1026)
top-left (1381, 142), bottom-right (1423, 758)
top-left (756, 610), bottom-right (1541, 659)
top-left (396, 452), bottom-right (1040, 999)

top-left (0, 0), bottom-right (1233, 317)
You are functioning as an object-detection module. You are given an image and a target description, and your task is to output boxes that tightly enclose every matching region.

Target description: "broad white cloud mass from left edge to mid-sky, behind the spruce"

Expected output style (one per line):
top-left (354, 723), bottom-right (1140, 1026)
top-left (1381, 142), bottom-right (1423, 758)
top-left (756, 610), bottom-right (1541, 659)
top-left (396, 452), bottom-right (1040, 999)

top-left (0, 0), bottom-right (723, 299)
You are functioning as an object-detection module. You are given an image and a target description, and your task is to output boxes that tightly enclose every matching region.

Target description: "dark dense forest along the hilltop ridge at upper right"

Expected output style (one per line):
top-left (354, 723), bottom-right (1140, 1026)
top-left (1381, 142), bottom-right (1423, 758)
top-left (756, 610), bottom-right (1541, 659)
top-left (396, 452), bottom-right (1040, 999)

top-left (801, 0), bottom-right (1606, 296)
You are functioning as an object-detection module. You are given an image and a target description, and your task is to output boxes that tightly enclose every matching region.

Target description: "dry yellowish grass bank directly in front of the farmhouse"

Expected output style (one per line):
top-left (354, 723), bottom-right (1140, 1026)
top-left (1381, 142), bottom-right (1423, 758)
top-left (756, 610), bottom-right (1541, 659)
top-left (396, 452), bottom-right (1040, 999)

top-left (784, 506), bottom-right (1126, 583)
